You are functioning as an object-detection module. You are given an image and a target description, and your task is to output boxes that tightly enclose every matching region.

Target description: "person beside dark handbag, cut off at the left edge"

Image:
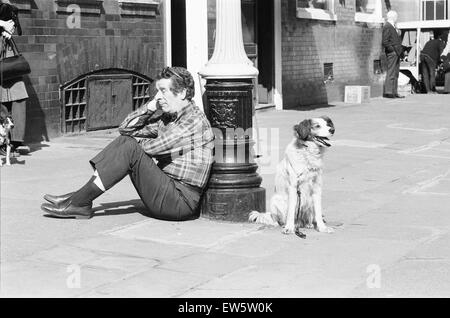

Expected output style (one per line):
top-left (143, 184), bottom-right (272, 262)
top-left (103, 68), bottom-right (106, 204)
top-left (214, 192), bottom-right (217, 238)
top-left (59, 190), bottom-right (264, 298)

top-left (0, 0), bottom-right (28, 156)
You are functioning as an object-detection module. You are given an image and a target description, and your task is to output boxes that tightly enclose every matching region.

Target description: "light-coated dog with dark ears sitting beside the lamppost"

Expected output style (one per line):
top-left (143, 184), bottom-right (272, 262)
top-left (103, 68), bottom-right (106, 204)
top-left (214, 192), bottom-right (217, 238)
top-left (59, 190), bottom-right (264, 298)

top-left (249, 116), bottom-right (335, 236)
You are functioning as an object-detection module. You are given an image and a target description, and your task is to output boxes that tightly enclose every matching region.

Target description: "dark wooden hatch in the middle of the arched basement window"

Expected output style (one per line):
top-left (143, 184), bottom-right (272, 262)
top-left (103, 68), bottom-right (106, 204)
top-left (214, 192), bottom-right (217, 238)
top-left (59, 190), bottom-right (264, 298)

top-left (86, 75), bottom-right (133, 130)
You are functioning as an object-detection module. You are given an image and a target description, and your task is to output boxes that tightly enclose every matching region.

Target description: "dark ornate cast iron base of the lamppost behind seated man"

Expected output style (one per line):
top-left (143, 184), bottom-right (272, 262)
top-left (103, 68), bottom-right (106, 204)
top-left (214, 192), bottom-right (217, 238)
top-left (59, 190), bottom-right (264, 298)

top-left (201, 79), bottom-right (266, 222)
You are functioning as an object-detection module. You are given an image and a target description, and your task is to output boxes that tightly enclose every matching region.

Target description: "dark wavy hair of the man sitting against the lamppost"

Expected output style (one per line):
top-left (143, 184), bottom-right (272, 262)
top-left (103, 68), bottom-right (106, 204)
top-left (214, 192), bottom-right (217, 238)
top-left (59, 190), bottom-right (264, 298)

top-left (156, 66), bottom-right (195, 101)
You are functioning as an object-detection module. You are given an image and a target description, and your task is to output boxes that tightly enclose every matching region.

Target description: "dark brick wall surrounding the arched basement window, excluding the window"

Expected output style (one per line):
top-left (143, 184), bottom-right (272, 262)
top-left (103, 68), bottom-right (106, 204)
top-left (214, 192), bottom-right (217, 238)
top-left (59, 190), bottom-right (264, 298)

top-left (11, 0), bottom-right (164, 141)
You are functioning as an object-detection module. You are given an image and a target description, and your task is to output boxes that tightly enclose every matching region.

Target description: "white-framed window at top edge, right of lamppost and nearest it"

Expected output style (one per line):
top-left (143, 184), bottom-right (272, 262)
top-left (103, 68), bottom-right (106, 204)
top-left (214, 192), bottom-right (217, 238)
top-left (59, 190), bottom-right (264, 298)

top-left (297, 0), bottom-right (337, 21)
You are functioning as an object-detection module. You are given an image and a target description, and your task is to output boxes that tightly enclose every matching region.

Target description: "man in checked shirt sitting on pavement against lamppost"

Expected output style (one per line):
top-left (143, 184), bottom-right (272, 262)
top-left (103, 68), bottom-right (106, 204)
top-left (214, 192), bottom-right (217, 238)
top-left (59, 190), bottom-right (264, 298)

top-left (41, 67), bottom-right (214, 221)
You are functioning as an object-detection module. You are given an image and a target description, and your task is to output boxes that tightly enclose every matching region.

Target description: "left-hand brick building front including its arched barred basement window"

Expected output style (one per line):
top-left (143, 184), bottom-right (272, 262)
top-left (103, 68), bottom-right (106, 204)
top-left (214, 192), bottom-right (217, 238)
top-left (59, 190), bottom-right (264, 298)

top-left (10, 0), bottom-right (165, 142)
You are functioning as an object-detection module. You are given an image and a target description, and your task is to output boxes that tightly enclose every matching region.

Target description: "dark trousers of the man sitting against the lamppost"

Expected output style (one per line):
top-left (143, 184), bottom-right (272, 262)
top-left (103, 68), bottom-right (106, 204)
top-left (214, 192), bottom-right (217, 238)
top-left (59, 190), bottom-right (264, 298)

top-left (89, 136), bottom-right (200, 221)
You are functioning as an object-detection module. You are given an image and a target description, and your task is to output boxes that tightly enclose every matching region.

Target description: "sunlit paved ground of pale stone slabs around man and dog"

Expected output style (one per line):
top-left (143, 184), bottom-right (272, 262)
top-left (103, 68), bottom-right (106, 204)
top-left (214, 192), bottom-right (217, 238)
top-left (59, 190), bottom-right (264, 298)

top-left (0, 94), bottom-right (450, 298)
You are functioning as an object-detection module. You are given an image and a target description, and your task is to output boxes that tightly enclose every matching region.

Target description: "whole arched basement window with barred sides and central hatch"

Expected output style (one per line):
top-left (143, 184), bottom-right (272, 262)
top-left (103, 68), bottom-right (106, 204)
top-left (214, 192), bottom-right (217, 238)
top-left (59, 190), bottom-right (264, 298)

top-left (60, 69), bottom-right (156, 133)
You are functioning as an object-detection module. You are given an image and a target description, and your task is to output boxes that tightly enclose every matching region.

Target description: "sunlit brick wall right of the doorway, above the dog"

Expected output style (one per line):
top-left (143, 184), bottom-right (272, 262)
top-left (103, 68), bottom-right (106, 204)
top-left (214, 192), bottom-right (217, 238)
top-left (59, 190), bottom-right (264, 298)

top-left (282, 0), bottom-right (385, 109)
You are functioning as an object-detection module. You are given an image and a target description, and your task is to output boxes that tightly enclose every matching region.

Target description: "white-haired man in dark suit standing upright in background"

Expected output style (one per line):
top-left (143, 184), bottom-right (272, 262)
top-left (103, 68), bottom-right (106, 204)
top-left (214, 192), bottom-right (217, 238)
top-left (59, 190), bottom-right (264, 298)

top-left (382, 11), bottom-right (404, 98)
